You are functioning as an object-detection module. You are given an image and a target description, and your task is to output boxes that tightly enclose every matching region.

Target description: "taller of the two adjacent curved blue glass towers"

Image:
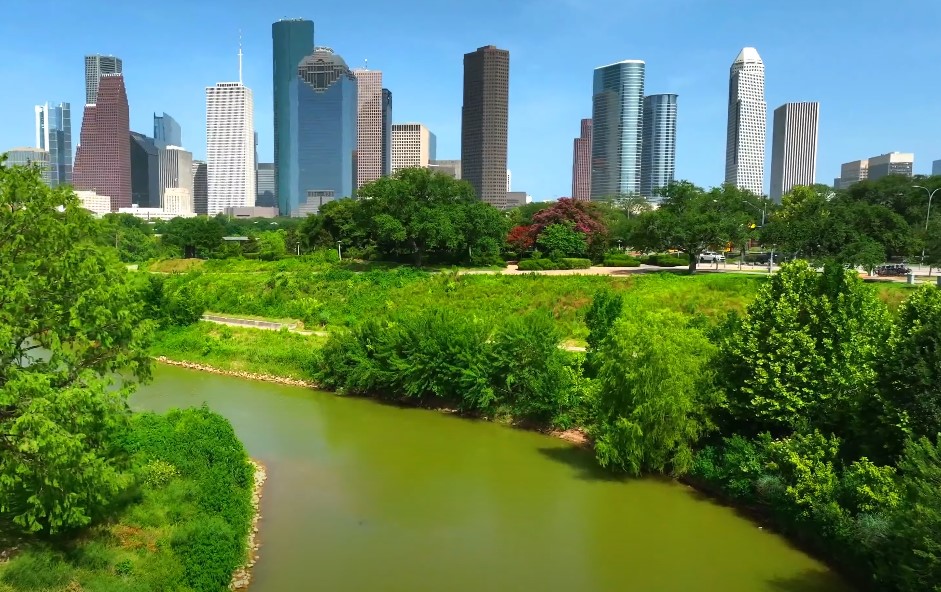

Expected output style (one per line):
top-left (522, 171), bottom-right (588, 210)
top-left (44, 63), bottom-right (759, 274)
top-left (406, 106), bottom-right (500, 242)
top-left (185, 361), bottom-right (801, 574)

top-left (591, 60), bottom-right (646, 199)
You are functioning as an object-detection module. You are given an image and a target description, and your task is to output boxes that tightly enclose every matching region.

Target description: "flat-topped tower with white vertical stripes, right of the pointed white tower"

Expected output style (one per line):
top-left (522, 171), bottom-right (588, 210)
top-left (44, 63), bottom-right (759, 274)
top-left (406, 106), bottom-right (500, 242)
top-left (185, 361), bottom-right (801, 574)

top-left (769, 103), bottom-right (820, 202)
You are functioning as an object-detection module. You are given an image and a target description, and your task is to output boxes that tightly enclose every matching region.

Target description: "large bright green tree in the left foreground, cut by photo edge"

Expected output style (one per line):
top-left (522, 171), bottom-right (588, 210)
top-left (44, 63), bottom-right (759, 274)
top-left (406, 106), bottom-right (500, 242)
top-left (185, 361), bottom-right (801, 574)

top-left (0, 161), bottom-right (150, 533)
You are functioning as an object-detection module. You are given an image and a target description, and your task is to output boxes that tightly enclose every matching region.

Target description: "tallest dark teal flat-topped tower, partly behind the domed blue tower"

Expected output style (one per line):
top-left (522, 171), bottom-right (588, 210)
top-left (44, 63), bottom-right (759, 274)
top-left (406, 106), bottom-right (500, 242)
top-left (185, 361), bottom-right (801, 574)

top-left (271, 19), bottom-right (314, 216)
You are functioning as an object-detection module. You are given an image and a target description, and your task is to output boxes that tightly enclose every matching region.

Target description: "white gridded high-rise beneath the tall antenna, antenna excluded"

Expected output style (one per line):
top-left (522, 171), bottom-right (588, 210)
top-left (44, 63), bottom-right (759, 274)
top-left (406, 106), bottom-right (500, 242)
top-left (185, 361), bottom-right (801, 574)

top-left (206, 82), bottom-right (255, 216)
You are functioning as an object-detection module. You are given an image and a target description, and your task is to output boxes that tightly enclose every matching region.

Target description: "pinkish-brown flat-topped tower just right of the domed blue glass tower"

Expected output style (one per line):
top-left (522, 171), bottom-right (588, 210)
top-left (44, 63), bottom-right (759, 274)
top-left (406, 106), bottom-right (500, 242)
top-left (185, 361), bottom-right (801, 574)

top-left (353, 68), bottom-right (383, 189)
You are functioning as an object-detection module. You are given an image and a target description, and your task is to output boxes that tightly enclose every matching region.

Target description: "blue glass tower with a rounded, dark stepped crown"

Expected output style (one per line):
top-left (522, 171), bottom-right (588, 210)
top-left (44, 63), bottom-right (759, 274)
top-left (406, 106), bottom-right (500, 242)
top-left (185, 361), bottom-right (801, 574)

top-left (288, 47), bottom-right (357, 216)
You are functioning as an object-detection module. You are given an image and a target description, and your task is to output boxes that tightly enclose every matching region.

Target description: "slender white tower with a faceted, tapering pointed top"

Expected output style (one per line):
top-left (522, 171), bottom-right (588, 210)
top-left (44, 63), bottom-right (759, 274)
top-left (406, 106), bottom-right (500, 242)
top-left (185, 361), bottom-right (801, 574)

top-left (725, 47), bottom-right (768, 195)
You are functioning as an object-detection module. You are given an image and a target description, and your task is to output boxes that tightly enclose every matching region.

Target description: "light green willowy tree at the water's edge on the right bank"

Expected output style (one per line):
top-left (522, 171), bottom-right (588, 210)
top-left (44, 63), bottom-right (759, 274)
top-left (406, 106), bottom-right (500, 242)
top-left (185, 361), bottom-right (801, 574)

top-left (591, 310), bottom-right (716, 475)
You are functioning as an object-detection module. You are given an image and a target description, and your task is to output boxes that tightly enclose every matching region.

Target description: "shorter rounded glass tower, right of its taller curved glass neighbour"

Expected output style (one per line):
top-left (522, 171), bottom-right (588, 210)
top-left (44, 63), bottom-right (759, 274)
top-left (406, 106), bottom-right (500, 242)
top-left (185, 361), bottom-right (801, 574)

top-left (640, 94), bottom-right (677, 201)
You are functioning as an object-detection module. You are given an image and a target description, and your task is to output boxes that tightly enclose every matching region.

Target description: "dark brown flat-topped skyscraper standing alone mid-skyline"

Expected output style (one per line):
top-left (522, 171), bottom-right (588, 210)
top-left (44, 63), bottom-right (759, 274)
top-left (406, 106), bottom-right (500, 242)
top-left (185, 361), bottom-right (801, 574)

top-left (461, 45), bottom-right (510, 208)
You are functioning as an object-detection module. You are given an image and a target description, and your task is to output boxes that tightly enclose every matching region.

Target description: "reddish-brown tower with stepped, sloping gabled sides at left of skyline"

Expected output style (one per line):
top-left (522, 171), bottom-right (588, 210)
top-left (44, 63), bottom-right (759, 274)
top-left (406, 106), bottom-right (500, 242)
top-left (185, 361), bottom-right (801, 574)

top-left (72, 74), bottom-right (131, 212)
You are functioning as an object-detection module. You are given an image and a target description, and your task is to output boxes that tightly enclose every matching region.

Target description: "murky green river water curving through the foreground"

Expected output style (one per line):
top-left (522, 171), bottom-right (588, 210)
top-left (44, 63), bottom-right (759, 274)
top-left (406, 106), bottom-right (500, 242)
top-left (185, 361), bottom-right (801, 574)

top-left (132, 366), bottom-right (846, 592)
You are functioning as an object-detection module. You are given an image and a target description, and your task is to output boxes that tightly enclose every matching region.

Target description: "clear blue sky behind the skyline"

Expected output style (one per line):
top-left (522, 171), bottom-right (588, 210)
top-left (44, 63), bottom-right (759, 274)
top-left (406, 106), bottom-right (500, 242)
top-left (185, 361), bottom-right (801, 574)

top-left (0, 0), bottom-right (941, 200)
